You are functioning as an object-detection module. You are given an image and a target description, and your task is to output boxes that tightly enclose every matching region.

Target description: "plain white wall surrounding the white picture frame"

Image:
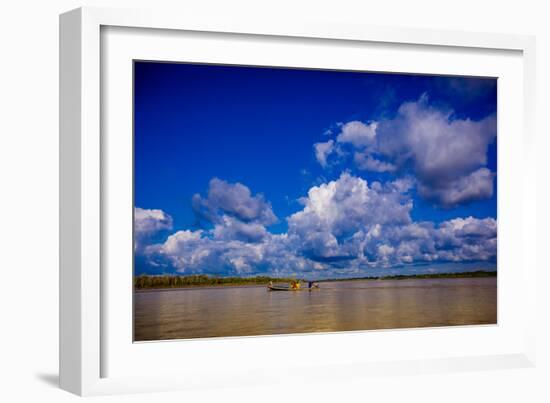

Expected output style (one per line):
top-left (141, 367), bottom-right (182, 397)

top-left (0, 0), bottom-right (550, 403)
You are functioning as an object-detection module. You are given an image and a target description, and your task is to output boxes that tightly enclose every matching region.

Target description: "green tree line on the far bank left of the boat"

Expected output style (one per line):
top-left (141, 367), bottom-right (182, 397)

top-left (134, 274), bottom-right (304, 289)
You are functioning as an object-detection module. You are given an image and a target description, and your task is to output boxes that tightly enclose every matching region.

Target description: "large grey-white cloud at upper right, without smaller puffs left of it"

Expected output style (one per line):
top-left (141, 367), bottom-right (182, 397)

top-left (377, 95), bottom-right (496, 207)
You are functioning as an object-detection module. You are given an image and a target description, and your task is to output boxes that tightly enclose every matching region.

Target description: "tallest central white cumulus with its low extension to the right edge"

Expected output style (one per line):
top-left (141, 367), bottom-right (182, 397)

top-left (288, 173), bottom-right (496, 268)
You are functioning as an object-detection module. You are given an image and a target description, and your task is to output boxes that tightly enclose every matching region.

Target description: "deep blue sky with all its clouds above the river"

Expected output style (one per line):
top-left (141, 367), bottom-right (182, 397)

top-left (134, 62), bottom-right (497, 278)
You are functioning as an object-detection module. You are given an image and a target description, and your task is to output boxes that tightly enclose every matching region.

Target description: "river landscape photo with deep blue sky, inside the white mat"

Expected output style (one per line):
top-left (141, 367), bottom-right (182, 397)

top-left (134, 61), bottom-right (497, 341)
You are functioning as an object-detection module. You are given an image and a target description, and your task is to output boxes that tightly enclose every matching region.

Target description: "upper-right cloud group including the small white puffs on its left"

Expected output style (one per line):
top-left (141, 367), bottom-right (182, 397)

top-left (317, 94), bottom-right (496, 208)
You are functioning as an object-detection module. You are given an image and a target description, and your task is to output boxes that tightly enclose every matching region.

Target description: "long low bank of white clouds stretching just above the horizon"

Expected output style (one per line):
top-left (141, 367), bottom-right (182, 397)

top-left (143, 172), bottom-right (497, 278)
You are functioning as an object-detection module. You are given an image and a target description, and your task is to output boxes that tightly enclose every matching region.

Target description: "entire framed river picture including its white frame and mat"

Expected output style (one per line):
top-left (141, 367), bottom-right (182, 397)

top-left (60, 9), bottom-right (536, 394)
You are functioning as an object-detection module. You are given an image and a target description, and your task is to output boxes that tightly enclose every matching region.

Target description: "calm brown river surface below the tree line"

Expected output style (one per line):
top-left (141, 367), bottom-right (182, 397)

top-left (134, 277), bottom-right (497, 341)
